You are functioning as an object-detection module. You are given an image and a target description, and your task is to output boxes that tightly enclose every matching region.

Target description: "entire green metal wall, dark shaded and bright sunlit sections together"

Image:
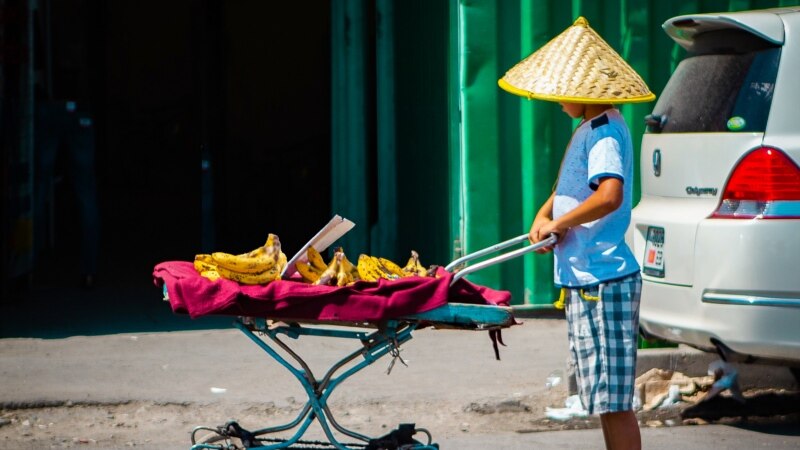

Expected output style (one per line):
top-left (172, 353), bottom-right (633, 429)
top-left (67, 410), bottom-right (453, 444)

top-left (331, 0), bottom-right (800, 306)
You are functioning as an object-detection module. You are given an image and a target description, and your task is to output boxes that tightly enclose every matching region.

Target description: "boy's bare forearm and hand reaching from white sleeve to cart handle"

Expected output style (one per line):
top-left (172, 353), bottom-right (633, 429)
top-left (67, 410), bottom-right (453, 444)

top-left (531, 177), bottom-right (623, 242)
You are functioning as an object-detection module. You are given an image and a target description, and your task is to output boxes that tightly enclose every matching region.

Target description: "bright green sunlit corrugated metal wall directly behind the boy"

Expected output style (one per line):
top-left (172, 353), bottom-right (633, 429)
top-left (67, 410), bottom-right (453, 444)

top-left (450, 0), bottom-right (798, 305)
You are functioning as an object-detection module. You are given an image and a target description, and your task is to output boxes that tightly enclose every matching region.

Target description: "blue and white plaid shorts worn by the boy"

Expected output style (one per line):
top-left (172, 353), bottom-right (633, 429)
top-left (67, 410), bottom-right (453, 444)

top-left (566, 272), bottom-right (642, 414)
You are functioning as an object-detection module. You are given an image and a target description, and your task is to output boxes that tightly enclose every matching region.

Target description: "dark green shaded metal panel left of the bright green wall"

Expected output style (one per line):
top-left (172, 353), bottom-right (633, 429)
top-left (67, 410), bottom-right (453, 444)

top-left (331, 0), bottom-right (455, 265)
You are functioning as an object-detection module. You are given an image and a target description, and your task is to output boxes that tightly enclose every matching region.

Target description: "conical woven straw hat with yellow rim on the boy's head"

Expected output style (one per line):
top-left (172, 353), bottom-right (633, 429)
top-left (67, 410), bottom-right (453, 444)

top-left (497, 17), bottom-right (656, 104)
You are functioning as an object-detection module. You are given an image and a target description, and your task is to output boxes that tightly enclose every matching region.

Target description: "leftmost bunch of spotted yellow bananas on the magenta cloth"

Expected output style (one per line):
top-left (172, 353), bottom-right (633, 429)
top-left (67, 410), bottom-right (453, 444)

top-left (194, 234), bottom-right (286, 284)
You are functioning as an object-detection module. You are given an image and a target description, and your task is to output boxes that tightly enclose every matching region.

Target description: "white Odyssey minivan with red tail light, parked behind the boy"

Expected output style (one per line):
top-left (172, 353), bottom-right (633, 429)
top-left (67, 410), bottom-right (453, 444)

top-left (628, 7), bottom-right (800, 376)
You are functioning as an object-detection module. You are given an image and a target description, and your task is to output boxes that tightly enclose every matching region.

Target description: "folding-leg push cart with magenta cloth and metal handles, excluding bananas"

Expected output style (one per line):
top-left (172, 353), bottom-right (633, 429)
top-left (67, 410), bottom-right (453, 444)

top-left (154, 230), bottom-right (556, 450)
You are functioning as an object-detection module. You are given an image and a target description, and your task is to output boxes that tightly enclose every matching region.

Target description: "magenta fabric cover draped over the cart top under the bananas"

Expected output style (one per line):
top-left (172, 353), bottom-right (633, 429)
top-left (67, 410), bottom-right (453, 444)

top-left (153, 261), bottom-right (511, 322)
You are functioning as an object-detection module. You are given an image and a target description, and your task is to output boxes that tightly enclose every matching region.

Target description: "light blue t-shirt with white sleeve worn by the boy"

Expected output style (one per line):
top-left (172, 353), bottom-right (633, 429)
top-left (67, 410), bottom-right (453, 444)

top-left (553, 108), bottom-right (639, 287)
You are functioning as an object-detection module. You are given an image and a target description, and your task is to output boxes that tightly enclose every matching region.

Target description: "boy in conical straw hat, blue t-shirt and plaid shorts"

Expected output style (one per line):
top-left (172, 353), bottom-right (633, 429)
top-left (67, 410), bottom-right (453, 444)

top-left (499, 18), bottom-right (655, 449)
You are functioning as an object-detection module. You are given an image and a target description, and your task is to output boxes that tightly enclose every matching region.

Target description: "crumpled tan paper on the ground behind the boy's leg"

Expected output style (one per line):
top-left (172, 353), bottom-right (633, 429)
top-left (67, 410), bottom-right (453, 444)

top-left (634, 368), bottom-right (714, 411)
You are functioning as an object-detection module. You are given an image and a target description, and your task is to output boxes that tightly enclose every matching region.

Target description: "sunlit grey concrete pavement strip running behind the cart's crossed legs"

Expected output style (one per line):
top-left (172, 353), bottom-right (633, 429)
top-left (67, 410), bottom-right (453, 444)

top-left (0, 316), bottom-right (794, 404)
